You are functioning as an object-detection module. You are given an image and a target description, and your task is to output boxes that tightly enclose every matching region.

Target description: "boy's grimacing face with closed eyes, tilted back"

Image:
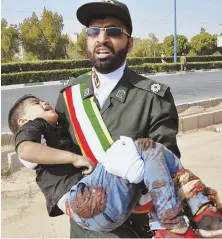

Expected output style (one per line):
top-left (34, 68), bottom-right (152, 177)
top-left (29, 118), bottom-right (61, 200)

top-left (18, 98), bottom-right (58, 126)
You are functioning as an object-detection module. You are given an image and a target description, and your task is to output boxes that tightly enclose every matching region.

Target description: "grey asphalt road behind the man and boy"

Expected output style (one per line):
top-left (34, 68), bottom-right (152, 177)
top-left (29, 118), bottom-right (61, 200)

top-left (1, 72), bottom-right (222, 132)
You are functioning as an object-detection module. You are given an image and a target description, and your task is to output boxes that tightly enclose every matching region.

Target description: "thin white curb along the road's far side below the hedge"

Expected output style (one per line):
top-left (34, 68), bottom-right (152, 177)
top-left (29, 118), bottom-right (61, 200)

top-left (1, 68), bottom-right (222, 90)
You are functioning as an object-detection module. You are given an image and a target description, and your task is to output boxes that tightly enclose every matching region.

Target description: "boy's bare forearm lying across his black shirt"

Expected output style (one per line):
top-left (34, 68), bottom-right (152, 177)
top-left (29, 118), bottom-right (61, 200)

top-left (17, 141), bottom-right (78, 164)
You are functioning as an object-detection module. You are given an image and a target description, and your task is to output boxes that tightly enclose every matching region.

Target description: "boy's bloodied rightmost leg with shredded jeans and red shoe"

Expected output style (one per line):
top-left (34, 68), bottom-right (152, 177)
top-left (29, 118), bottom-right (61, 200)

top-left (162, 142), bottom-right (222, 237)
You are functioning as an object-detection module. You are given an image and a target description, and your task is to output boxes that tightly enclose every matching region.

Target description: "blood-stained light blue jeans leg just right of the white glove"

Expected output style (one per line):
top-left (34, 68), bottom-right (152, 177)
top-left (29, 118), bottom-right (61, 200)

top-left (138, 143), bottom-right (187, 230)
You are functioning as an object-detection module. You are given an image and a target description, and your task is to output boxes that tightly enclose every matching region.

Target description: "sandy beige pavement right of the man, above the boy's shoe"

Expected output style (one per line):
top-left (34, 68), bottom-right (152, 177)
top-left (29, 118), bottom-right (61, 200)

top-left (177, 124), bottom-right (222, 200)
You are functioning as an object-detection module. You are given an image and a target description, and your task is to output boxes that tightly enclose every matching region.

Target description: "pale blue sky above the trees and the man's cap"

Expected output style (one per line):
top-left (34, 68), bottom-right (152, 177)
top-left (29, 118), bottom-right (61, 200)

top-left (1, 0), bottom-right (222, 41)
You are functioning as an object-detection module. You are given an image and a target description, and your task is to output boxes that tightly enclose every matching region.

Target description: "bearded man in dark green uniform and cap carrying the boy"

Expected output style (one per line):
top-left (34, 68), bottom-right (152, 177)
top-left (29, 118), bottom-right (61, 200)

top-left (56, 0), bottom-right (180, 238)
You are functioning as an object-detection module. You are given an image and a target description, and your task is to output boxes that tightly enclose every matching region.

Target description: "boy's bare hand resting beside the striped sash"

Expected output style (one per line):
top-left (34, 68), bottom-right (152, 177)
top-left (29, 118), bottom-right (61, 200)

top-left (72, 155), bottom-right (95, 175)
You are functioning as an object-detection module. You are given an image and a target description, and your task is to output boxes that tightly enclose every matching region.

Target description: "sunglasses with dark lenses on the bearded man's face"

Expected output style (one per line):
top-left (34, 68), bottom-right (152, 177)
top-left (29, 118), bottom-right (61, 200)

top-left (86, 27), bottom-right (131, 37)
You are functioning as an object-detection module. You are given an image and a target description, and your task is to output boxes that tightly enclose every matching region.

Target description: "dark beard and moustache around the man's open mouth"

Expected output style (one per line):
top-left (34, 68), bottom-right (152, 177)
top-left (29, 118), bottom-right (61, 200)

top-left (87, 41), bottom-right (129, 74)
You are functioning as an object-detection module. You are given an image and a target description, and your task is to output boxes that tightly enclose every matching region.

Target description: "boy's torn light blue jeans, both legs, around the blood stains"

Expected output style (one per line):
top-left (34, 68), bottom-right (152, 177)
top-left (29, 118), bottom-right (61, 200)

top-left (68, 143), bottom-right (210, 232)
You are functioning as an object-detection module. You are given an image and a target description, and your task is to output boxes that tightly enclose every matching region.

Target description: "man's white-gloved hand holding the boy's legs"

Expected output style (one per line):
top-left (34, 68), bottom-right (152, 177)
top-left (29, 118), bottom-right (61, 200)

top-left (102, 136), bottom-right (144, 183)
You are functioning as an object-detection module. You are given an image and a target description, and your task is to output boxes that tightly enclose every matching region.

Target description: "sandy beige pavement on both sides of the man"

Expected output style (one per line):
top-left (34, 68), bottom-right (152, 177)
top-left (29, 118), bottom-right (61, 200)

top-left (2, 124), bottom-right (222, 238)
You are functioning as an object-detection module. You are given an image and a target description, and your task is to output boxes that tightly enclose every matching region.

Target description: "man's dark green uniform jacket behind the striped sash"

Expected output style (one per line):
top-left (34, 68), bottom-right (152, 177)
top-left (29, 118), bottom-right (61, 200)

top-left (56, 67), bottom-right (180, 157)
